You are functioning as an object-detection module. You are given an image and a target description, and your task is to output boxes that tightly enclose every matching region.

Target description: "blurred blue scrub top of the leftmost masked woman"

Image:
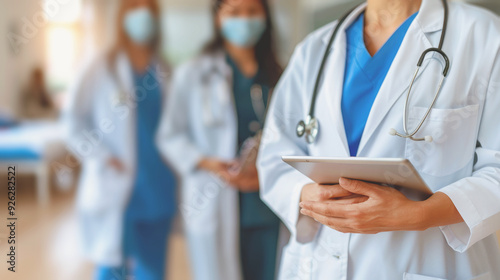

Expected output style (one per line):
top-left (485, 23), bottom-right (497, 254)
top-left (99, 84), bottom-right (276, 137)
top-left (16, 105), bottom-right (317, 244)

top-left (127, 67), bottom-right (177, 220)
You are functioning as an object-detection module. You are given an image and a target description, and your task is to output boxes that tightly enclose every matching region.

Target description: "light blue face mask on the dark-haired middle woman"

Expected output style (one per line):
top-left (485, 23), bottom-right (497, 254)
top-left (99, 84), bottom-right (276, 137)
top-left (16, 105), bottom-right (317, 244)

top-left (221, 17), bottom-right (266, 48)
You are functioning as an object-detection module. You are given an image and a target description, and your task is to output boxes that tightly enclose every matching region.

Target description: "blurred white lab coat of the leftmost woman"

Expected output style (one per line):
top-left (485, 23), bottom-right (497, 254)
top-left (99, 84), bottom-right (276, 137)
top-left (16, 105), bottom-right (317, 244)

top-left (66, 52), bottom-right (167, 266)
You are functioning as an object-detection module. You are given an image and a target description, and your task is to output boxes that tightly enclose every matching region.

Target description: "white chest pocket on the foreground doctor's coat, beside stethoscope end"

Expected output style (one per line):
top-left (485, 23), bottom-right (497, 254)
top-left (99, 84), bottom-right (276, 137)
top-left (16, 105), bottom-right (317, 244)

top-left (405, 105), bottom-right (479, 177)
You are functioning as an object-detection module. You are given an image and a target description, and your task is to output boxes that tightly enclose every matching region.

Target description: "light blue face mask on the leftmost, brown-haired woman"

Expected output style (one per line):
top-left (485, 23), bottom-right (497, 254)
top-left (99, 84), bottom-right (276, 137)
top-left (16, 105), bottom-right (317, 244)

top-left (123, 8), bottom-right (156, 45)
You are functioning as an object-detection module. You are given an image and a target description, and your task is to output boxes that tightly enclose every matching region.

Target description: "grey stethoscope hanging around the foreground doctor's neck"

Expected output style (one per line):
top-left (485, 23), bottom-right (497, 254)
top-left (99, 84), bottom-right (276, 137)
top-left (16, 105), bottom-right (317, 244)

top-left (297, 0), bottom-right (450, 144)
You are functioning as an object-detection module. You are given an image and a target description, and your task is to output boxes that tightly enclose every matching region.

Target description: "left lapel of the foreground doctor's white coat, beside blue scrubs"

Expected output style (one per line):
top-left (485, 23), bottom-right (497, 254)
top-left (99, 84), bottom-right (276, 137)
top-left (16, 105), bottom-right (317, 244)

top-left (318, 4), bottom-right (366, 157)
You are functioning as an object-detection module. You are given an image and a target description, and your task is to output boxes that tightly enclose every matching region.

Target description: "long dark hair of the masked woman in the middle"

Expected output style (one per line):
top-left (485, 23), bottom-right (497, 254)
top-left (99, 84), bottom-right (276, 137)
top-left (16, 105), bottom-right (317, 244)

top-left (204, 0), bottom-right (283, 87)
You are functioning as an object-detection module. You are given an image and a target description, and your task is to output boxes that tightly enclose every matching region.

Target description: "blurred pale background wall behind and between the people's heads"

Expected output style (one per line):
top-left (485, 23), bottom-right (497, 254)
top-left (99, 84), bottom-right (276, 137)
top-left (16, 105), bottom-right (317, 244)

top-left (0, 0), bottom-right (500, 115)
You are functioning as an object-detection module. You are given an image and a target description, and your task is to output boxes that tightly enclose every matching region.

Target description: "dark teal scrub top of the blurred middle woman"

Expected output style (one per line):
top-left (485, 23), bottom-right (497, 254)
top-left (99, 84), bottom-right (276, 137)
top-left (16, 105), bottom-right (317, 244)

top-left (226, 55), bottom-right (279, 228)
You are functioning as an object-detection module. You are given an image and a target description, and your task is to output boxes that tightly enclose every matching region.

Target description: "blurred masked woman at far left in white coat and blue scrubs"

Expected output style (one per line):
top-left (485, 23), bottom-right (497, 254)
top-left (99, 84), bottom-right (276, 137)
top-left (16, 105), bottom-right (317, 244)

top-left (68, 0), bottom-right (176, 280)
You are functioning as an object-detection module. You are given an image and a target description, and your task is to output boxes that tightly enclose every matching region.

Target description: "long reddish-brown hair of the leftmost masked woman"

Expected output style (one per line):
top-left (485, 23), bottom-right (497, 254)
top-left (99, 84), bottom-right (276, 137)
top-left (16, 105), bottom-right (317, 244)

top-left (109, 0), bottom-right (161, 62)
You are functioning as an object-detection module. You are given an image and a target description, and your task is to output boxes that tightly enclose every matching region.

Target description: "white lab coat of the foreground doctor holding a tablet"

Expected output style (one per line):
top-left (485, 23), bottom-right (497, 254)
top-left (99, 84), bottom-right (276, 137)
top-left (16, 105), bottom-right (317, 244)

top-left (258, 0), bottom-right (500, 280)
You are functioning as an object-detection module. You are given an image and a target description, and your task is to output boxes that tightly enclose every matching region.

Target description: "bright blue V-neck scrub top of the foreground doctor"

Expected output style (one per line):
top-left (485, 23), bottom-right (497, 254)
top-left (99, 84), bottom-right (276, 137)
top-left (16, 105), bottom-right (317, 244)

top-left (341, 13), bottom-right (418, 157)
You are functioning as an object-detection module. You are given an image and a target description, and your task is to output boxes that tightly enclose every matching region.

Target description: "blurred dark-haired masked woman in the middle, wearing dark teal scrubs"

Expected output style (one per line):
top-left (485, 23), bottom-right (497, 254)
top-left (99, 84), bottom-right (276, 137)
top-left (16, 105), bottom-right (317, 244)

top-left (158, 0), bottom-right (282, 280)
